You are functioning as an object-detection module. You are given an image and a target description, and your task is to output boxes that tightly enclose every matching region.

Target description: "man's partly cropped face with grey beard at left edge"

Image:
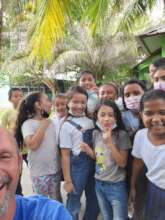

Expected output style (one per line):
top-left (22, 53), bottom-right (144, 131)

top-left (0, 128), bottom-right (21, 217)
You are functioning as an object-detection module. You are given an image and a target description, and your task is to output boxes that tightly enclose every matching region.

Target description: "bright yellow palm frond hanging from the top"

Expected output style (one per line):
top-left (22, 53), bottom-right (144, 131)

top-left (30, 0), bottom-right (68, 62)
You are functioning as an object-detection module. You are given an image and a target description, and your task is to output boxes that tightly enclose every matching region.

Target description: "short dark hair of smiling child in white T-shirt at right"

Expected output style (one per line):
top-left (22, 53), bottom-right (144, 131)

top-left (140, 89), bottom-right (165, 112)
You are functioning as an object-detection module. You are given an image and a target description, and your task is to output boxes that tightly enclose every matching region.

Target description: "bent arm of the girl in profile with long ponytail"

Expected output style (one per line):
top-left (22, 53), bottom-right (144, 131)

top-left (24, 119), bottom-right (50, 150)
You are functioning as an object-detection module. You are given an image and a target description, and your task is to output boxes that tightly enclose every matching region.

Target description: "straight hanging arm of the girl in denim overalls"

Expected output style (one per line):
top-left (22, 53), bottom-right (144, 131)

top-left (61, 148), bottom-right (74, 193)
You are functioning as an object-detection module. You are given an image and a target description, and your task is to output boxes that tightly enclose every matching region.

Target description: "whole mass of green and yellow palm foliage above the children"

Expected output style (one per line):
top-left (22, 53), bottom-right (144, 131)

top-left (0, 0), bottom-right (163, 92)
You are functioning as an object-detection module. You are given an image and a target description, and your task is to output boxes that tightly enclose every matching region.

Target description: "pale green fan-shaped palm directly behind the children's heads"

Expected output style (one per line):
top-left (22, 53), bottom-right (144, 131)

top-left (49, 26), bottom-right (138, 80)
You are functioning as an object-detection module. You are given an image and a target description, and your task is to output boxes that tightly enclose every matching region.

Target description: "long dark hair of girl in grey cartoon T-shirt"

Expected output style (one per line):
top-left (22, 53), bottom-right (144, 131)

top-left (95, 100), bottom-right (125, 130)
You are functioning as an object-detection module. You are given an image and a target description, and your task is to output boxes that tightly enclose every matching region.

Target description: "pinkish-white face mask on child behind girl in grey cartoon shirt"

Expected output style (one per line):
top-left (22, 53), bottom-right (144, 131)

top-left (125, 95), bottom-right (142, 110)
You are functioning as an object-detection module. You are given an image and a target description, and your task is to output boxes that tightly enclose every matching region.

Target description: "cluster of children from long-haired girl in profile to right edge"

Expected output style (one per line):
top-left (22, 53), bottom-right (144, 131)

top-left (0, 62), bottom-right (165, 220)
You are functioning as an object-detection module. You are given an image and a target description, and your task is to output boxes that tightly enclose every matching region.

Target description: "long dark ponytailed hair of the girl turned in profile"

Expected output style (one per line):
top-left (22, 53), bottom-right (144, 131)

top-left (15, 92), bottom-right (42, 148)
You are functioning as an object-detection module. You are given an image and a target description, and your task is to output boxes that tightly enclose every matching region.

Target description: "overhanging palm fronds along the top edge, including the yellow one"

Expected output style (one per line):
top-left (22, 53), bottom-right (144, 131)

top-left (27, 0), bottom-right (160, 62)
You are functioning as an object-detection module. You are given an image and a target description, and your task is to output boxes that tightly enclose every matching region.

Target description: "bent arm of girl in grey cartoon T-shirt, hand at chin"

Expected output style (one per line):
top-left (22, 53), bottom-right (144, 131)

top-left (103, 129), bottom-right (128, 167)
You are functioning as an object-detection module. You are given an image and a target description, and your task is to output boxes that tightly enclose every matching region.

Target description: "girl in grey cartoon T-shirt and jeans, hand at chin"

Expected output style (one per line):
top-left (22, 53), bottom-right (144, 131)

top-left (82, 100), bottom-right (131, 220)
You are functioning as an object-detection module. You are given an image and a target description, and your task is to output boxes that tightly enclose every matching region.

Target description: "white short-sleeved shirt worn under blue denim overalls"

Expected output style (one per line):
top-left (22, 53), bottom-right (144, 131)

top-left (59, 116), bottom-right (94, 156)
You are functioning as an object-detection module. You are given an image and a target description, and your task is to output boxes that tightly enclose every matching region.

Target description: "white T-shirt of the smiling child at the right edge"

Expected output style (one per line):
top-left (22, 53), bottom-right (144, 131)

top-left (132, 128), bottom-right (165, 190)
